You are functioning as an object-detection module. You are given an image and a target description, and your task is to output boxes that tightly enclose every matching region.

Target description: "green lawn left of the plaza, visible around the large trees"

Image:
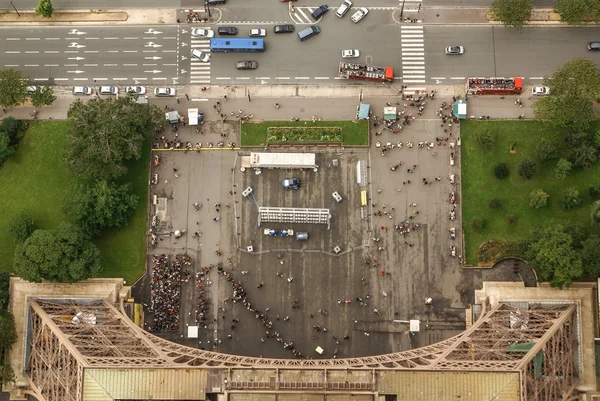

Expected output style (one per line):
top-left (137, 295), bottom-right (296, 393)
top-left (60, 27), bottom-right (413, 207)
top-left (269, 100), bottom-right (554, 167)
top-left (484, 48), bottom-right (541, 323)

top-left (0, 121), bottom-right (149, 283)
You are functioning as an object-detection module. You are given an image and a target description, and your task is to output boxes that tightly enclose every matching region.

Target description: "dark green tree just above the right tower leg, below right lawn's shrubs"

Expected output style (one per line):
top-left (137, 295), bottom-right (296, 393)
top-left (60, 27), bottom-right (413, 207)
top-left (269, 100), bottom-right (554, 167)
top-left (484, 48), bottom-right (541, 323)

top-left (525, 223), bottom-right (583, 288)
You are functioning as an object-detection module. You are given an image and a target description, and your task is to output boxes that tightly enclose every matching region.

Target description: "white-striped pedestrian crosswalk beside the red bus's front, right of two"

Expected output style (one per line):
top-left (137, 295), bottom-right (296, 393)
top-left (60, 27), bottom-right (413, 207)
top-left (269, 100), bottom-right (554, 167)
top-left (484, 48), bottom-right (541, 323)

top-left (400, 25), bottom-right (425, 84)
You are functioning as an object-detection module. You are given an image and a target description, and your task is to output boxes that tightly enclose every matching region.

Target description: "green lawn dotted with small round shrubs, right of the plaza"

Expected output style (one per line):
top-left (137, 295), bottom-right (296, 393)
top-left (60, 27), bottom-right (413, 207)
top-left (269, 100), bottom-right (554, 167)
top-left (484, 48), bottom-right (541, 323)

top-left (461, 120), bottom-right (600, 264)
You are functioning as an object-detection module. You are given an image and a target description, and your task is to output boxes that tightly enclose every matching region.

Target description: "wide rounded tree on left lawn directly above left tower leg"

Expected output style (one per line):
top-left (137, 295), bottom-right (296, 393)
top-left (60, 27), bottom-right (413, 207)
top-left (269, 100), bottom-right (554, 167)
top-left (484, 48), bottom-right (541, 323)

top-left (15, 223), bottom-right (102, 283)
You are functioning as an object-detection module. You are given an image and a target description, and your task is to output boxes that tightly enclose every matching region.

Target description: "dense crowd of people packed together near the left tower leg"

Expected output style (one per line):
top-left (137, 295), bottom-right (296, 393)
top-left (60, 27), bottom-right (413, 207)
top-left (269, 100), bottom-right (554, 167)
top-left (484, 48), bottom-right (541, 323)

top-left (148, 254), bottom-right (192, 331)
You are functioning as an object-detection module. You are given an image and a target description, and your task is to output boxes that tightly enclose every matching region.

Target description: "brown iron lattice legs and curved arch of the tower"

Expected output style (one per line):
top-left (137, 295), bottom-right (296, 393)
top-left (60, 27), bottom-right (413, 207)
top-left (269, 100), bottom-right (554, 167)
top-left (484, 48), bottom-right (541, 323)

top-left (27, 299), bottom-right (579, 401)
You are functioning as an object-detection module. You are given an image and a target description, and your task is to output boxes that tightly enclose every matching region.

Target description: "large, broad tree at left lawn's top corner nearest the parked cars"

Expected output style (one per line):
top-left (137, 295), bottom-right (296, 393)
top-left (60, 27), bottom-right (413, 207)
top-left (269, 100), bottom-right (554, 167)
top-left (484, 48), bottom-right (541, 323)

top-left (65, 96), bottom-right (166, 179)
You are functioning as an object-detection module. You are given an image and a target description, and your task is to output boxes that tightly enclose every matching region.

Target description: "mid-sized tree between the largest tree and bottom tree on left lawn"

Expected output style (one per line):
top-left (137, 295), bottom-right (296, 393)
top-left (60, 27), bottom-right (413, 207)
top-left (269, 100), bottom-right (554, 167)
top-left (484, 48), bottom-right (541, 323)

top-left (62, 180), bottom-right (138, 235)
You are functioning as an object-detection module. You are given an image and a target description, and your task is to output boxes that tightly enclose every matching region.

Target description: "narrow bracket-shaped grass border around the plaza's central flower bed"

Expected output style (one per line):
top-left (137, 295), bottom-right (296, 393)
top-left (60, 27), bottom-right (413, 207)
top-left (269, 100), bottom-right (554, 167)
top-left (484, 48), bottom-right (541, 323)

top-left (241, 120), bottom-right (369, 146)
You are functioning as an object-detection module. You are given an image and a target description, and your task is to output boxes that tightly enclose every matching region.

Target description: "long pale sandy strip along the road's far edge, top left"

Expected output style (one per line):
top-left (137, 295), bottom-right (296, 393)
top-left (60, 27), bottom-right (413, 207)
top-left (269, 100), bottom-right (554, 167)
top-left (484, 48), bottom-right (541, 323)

top-left (0, 10), bottom-right (129, 24)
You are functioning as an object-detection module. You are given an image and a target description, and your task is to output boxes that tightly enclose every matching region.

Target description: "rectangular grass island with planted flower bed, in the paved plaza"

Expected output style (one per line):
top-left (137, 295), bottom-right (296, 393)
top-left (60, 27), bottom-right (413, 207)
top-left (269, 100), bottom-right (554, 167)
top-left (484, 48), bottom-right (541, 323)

top-left (241, 120), bottom-right (369, 147)
